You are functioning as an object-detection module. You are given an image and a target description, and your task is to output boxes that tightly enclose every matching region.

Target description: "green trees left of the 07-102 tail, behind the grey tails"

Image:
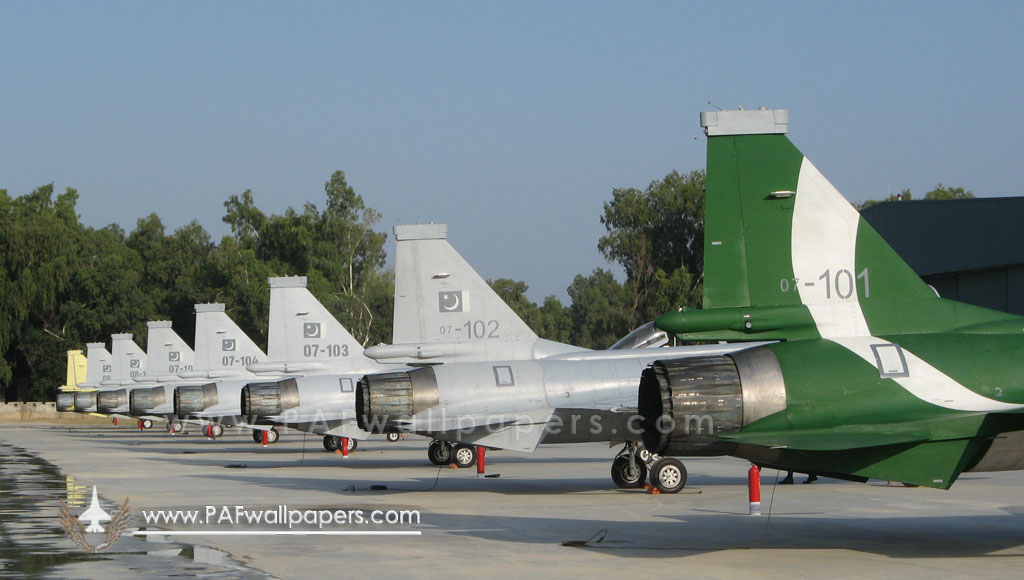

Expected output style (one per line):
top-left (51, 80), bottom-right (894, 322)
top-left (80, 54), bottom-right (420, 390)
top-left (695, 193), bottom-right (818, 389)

top-left (0, 171), bottom-right (394, 400)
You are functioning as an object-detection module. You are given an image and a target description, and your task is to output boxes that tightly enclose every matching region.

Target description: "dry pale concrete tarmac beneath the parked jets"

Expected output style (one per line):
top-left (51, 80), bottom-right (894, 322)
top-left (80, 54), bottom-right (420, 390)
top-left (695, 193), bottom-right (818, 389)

top-left (0, 425), bottom-right (1024, 579)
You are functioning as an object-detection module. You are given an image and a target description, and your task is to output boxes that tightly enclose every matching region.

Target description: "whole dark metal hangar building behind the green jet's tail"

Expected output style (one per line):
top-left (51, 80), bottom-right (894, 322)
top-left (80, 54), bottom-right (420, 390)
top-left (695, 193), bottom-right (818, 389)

top-left (861, 197), bottom-right (1024, 316)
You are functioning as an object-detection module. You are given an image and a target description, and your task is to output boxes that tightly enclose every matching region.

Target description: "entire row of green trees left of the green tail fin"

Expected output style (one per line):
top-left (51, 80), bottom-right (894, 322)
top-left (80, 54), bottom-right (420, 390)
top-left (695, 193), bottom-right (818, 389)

top-left (0, 171), bottom-right (703, 401)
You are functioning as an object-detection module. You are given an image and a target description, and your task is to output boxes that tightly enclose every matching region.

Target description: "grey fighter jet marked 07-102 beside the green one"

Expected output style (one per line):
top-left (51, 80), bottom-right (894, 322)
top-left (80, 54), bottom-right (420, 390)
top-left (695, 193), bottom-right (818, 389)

top-left (355, 224), bottom-right (765, 487)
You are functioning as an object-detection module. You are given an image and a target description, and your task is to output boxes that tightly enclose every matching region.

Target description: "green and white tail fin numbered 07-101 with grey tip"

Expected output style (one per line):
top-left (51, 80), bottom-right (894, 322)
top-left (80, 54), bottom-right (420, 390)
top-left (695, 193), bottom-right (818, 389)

top-left (658, 110), bottom-right (1016, 339)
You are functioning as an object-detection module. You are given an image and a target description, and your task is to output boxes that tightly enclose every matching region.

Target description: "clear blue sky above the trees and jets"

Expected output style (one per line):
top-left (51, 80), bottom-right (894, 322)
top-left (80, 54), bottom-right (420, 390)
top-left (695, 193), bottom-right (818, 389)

top-left (0, 1), bottom-right (1024, 301)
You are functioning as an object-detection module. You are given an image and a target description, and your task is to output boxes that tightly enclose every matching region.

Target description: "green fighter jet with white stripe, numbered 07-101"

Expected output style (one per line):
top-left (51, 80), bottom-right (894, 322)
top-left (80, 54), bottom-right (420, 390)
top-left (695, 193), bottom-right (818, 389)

top-left (639, 110), bottom-right (1024, 489)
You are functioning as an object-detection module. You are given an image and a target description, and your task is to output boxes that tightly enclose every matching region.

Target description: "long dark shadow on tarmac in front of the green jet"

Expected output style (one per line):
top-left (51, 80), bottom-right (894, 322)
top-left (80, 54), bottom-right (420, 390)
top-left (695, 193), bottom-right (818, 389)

top-left (413, 507), bottom-right (1024, 558)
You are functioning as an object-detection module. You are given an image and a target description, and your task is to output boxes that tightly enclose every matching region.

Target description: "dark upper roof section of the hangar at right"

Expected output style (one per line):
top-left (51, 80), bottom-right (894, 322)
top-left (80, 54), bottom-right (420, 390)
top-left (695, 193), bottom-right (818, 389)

top-left (860, 197), bottom-right (1024, 276)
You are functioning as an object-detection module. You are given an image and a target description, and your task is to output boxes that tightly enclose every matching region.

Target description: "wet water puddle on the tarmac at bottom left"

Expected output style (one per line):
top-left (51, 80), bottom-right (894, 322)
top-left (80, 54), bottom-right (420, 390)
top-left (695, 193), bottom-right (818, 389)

top-left (0, 444), bottom-right (272, 579)
